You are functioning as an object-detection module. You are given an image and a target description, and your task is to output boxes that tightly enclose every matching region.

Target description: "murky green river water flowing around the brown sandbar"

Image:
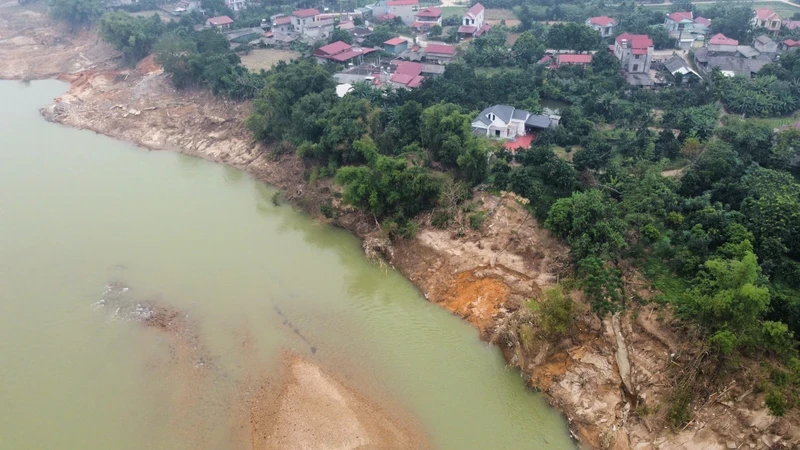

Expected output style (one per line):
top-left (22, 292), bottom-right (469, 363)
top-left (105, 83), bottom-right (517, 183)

top-left (0, 81), bottom-right (575, 450)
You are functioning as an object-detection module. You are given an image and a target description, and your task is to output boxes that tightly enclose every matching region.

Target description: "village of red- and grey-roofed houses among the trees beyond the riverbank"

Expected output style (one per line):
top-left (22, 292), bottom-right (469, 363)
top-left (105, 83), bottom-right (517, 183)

top-left (155, 0), bottom-right (800, 151)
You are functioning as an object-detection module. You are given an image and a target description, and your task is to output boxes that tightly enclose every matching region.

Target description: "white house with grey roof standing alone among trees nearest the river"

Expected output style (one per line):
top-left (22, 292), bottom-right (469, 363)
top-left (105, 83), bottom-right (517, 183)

top-left (472, 105), bottom-right (558, 139)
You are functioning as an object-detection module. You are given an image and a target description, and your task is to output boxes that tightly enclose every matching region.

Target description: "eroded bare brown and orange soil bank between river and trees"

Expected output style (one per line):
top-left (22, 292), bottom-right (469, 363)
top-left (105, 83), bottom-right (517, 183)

top-left (0, 5), bottom-right (800, 449)
